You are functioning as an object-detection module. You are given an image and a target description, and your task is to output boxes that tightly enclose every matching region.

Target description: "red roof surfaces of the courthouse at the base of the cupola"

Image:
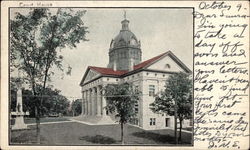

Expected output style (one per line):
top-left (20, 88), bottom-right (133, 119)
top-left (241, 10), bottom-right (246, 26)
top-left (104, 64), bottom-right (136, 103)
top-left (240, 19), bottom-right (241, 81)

top-left (89, 52), bottom-right (168, 76)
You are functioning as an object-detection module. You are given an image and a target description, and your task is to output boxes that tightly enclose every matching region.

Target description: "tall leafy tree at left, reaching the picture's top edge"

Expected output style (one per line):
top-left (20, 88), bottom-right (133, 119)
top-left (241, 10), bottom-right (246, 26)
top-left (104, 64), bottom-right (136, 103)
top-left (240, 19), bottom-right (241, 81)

top-left (10, 8), bottom-right (88, 143)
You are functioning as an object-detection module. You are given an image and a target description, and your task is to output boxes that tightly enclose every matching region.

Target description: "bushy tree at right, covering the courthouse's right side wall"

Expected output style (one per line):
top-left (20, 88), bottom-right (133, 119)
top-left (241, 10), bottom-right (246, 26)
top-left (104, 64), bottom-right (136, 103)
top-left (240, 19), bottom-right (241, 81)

top-left (150, 72), bottom-right (193, 143)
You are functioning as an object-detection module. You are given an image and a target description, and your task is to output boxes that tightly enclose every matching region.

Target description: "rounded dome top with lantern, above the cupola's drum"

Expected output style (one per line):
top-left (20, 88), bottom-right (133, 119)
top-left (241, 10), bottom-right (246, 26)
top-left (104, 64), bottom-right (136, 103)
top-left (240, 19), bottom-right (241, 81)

top-left (110, 19), bottom-right (140, 50)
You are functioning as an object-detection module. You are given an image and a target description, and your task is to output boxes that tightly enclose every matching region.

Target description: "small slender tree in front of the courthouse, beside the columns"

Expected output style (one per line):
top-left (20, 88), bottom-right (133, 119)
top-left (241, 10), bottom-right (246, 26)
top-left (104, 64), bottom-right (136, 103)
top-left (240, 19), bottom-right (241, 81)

top-left (104, 83), bottom-right (139, 144)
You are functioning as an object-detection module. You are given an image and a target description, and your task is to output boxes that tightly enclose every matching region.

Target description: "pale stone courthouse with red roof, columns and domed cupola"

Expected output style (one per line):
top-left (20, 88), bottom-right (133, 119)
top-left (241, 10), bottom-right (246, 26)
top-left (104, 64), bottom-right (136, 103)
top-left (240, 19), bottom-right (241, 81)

top-left (80, 15), bottom-right (191, 130)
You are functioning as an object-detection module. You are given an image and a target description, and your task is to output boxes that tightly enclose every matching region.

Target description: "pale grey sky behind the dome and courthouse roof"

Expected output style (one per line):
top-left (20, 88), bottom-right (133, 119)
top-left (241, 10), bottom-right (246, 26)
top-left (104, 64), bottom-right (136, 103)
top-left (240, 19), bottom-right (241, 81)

top-left (11, 8), bottom-right (193, 99)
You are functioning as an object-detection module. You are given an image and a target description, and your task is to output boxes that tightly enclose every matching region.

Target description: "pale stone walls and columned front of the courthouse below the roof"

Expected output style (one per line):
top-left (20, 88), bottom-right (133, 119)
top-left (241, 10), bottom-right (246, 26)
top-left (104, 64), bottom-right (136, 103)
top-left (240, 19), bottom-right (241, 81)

top-left (82, 68), bottom-right (190, 130)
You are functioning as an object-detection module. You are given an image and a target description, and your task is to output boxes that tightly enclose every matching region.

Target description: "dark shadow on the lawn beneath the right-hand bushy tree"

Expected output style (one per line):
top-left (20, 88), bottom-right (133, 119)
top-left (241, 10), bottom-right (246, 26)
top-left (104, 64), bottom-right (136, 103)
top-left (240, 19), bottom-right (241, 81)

top-left (132, 131), bottom-right (175, 144)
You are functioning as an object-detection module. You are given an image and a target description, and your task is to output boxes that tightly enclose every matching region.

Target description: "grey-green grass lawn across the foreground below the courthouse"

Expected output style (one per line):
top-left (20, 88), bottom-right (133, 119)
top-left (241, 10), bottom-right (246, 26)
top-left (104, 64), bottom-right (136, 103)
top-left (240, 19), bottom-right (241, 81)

top-left (11, 122), bottom-right (192, 146)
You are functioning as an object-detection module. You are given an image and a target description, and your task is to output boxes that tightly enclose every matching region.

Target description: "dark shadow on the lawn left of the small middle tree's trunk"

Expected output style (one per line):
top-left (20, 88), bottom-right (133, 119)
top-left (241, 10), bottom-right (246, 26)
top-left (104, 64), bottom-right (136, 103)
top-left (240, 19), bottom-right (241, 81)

top-left (79, 135), bottom-right (116, 144)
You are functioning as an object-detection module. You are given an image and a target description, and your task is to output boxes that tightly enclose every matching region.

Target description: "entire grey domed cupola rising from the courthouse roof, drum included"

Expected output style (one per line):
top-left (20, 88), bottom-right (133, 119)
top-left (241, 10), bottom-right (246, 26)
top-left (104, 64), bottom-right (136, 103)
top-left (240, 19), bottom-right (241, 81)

top-left (108, 12), bottom-right (141, 70)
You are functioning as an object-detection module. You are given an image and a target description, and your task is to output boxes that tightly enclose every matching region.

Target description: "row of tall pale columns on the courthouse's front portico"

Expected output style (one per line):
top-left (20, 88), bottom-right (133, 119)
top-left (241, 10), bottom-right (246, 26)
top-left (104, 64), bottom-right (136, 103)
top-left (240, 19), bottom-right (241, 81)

top-left (82, 86), bottom-right (107, 116)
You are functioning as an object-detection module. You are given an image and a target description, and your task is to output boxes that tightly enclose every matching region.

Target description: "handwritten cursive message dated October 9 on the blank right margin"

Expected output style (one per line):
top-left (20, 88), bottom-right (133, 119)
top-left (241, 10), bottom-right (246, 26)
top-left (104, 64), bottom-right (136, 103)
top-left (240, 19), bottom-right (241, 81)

top-left (194, 1), bottom-right (249, 149)
